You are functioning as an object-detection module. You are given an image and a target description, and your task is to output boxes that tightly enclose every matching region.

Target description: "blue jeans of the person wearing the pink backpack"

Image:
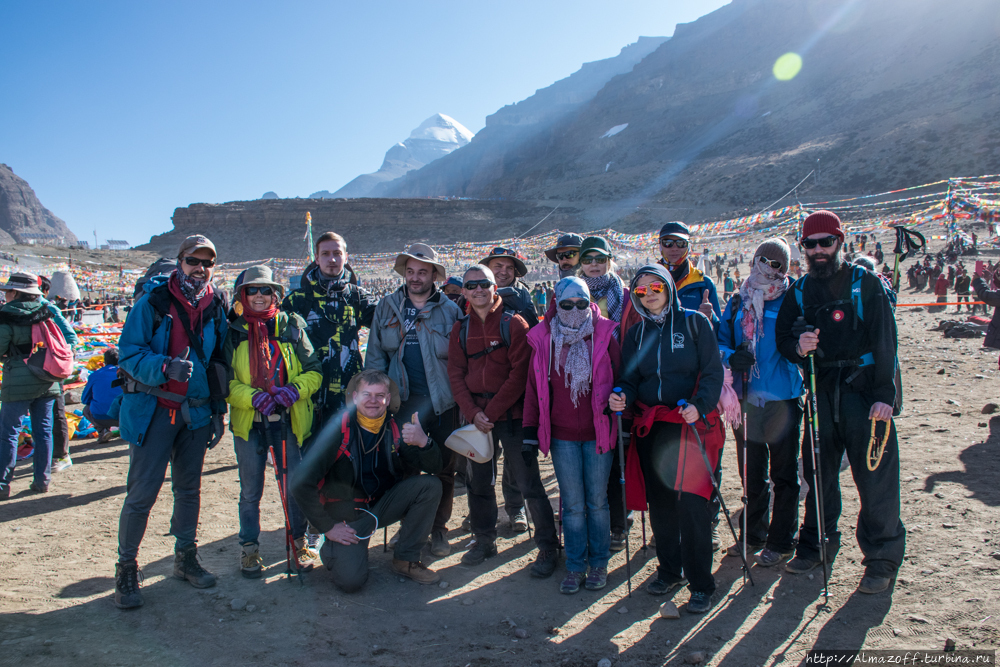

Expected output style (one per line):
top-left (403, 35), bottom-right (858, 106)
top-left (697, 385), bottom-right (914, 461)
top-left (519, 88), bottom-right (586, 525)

top-left (0, 396), bottom-right (56, 491)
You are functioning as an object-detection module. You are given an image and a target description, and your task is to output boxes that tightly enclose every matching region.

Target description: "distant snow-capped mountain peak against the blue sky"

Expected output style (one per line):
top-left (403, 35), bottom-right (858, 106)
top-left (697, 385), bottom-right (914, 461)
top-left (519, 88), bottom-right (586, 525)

top-left (318, 113), bottom-right (472, 199)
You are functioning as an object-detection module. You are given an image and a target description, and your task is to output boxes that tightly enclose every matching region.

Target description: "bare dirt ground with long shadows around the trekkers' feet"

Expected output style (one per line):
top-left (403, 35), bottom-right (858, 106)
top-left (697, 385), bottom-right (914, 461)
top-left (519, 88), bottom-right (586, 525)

top-left (0, 272), bottom-right (1000, 667)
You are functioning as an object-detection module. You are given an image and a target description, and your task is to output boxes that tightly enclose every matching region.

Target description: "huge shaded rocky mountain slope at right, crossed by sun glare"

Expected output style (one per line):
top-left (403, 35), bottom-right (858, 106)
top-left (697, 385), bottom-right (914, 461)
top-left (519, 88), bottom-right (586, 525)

top-left (378, 0), bottom-right (1000, 228)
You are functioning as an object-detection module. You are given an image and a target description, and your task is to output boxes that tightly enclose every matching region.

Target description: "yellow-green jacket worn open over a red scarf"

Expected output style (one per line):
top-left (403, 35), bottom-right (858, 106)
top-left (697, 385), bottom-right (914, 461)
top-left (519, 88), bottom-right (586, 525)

top-left (225, 311), bottom-right (323, 447)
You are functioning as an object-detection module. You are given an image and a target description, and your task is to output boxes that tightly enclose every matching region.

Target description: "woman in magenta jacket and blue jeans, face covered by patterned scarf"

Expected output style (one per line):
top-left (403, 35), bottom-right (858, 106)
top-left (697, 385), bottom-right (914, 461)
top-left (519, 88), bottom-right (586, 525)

top-left (523, 277), bottom-right (621, 595)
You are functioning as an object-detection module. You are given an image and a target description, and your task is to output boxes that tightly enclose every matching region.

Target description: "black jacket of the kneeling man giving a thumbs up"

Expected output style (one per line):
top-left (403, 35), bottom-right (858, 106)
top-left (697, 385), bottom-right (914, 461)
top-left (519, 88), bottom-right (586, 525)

top-left (290, 409), bottom-right (443, 533)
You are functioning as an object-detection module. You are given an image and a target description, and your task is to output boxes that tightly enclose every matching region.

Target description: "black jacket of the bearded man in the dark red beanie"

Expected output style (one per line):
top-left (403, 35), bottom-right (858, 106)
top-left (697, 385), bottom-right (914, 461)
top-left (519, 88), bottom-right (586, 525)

top-left (775, 264), bottom-right (896, 405)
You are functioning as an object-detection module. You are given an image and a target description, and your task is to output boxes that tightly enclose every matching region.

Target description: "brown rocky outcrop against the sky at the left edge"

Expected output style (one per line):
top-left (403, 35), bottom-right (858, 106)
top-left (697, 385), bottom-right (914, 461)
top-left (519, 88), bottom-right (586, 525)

top-left (0, 163), bottom-right (77, 245)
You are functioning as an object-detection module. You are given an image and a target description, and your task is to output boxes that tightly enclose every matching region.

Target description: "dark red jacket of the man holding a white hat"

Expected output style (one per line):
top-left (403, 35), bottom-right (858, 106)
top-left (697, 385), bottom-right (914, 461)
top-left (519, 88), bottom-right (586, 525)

top-left (448, 296), bottom-right (531, 424)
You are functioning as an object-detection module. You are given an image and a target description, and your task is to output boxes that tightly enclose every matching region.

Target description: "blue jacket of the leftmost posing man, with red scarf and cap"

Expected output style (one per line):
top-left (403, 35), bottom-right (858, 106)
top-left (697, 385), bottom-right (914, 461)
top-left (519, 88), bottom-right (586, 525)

top-left (109, 277), bottom-right (229, 446)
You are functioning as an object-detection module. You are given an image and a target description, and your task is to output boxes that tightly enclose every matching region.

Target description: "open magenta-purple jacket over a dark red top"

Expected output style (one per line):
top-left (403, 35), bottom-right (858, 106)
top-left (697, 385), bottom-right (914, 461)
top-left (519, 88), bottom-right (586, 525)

top-left (523, 303), bottom-right (618, 455)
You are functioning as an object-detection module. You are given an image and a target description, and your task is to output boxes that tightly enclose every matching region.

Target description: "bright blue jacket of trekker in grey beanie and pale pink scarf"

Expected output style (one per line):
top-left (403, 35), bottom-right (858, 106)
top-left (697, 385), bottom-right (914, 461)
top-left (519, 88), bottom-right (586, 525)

top-left (719, 292), bottom-right (804, 407)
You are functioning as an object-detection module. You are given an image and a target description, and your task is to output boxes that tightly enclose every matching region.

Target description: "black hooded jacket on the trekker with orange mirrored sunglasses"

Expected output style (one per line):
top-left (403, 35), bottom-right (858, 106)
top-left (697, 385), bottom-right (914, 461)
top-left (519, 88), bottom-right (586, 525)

top-left (619, 265), bottom-right (725, 415)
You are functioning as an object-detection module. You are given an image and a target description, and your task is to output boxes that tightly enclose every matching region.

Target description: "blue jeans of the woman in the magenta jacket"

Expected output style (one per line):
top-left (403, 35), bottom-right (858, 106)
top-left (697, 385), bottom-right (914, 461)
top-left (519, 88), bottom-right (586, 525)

top-left (550, 439), bottom-right (615, 572)
